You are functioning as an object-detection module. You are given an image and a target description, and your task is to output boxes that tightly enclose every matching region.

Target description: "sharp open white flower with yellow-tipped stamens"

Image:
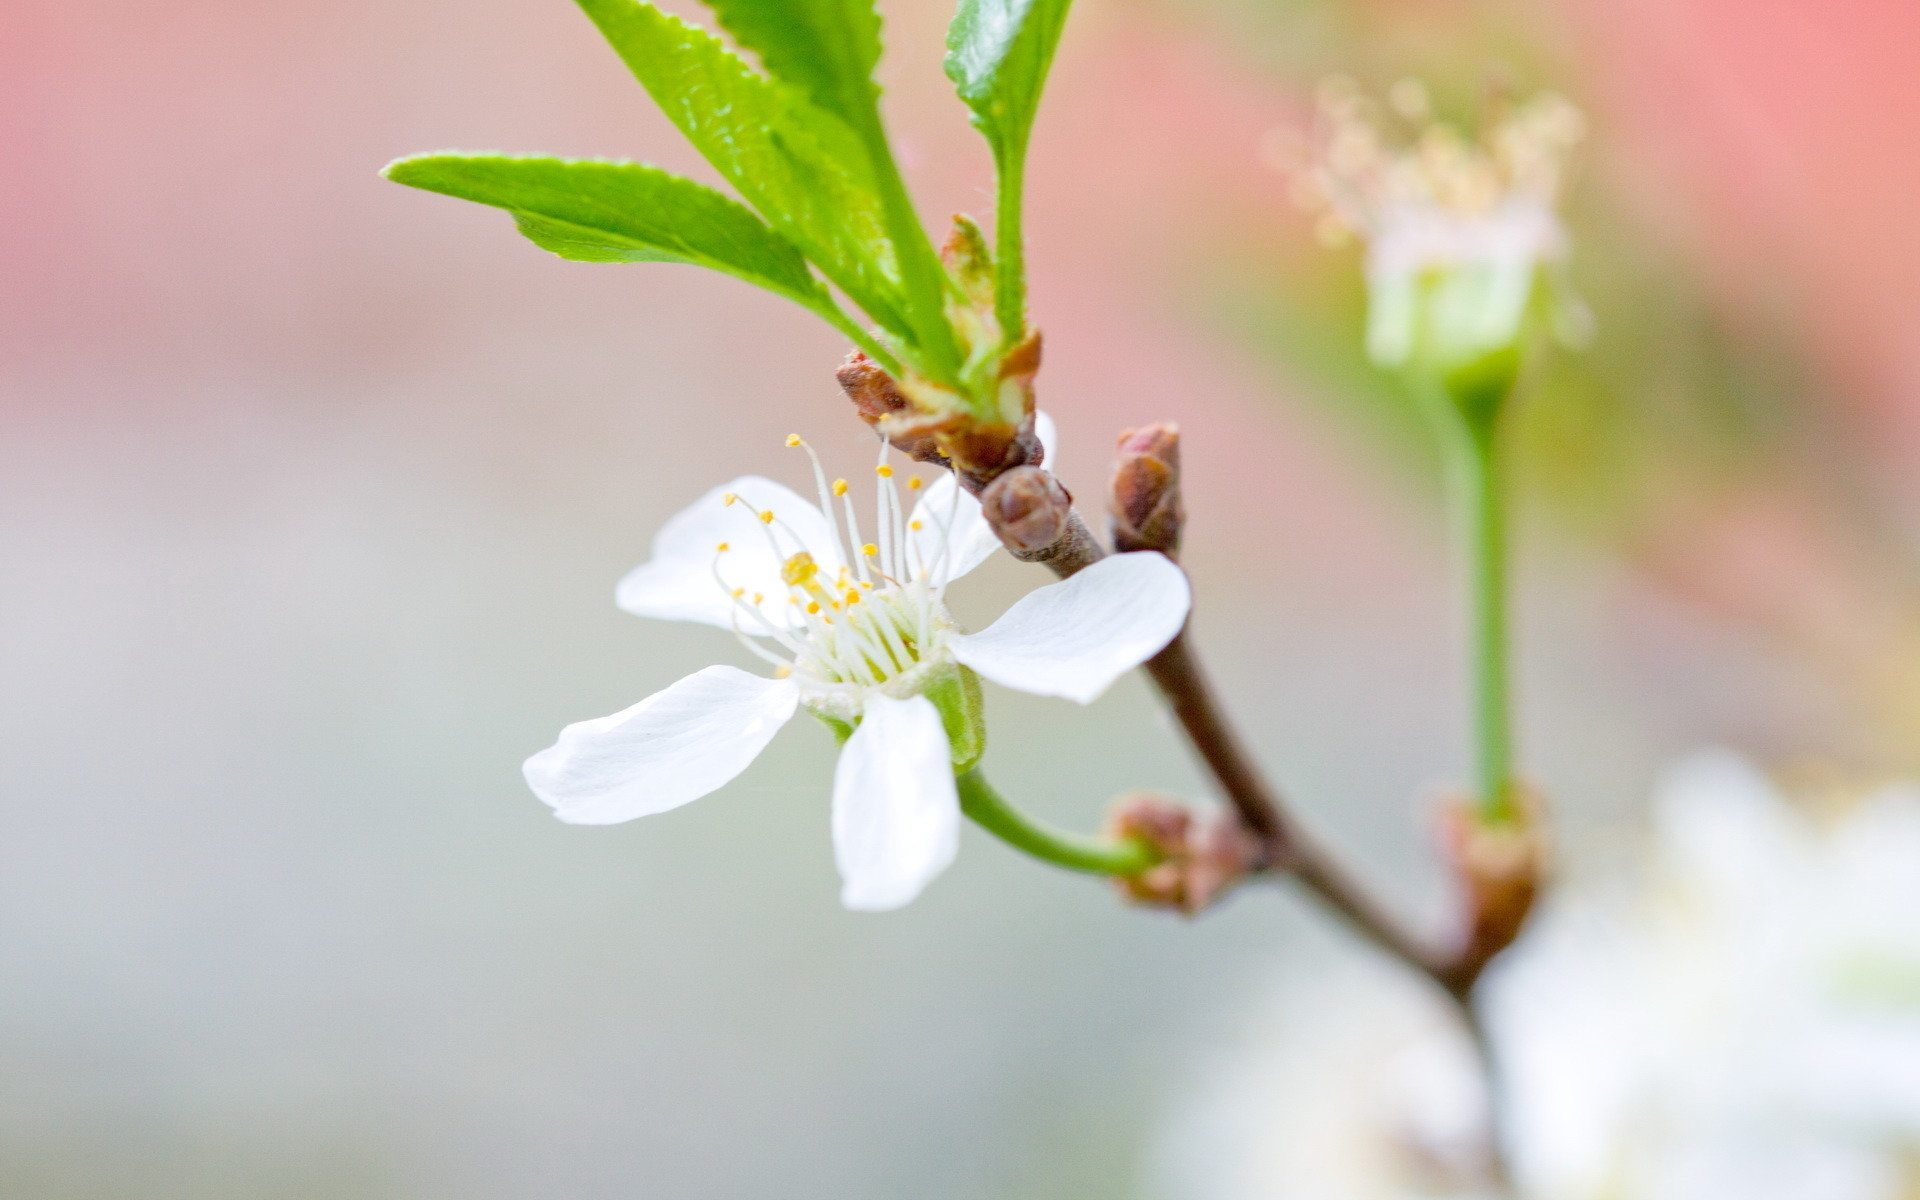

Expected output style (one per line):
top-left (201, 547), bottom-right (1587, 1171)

top-left (526, 417), bottom-right (1188, 910)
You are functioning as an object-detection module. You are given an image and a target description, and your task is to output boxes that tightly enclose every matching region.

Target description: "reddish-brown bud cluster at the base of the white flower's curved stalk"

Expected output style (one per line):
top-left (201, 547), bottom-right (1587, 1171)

top-left (1108, 793), bottom-right (1260, 916)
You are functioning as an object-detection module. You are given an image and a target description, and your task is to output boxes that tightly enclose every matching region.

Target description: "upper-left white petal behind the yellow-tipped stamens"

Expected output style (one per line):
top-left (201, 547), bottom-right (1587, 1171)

top-left (614, 474), bottom-right (841, 634)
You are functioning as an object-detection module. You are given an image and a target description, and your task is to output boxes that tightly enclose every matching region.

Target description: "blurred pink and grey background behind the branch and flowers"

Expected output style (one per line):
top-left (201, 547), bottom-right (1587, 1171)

top-left (0, 0), bottom-right (1920, 1200)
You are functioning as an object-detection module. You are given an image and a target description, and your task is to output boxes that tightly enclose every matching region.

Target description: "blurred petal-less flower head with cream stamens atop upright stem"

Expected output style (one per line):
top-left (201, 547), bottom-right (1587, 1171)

top-left (1304, 81), bottom-right (1588, 367)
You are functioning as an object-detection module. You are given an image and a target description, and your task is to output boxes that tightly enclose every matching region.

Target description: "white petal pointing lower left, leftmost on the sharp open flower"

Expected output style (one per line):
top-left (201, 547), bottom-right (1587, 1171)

top-left (524, 666), bottom-right (801, 826)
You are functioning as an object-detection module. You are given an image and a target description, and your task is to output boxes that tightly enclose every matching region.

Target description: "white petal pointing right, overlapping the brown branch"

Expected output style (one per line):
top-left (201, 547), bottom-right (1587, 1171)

top-left (948, 551), bottom-right (1192, 705)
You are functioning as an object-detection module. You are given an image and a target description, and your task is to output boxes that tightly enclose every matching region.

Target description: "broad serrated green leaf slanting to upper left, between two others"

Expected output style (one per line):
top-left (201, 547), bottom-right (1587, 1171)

top-left (578, 0), bottom-right (916, 344)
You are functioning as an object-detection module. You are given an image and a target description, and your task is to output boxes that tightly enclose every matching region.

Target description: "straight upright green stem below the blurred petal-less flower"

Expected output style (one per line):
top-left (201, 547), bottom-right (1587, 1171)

top-left (1453, 419), bottom-right (1517, 824)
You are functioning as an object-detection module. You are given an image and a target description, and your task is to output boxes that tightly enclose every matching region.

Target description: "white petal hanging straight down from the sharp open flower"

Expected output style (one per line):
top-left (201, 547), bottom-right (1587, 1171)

top-left (833, 693), bottom-right (960, 912)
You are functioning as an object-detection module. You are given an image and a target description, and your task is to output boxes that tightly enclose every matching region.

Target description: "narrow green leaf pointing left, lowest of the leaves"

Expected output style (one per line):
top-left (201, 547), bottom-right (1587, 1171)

top-left (384, 154), bottom-right (831, 309)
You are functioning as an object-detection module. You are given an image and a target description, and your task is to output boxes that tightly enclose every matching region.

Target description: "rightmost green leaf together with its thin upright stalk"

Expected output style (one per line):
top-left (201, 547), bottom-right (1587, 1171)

top-left (947, 0), bottom-right (1071, 342)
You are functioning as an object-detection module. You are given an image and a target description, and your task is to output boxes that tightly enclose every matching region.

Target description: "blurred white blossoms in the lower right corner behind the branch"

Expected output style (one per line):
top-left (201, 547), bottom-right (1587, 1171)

top-left (1167, 751), bottom-right (1920, 1200)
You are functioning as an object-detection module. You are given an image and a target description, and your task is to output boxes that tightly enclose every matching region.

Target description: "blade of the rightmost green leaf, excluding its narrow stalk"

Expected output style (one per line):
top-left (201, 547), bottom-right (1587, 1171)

top-left (947, 0), bottom-right (1069, 157)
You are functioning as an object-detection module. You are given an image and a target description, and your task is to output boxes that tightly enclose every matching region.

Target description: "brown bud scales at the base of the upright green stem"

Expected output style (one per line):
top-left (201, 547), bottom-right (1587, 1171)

top-left (1440, 785), bottom-right (1548, 972)
